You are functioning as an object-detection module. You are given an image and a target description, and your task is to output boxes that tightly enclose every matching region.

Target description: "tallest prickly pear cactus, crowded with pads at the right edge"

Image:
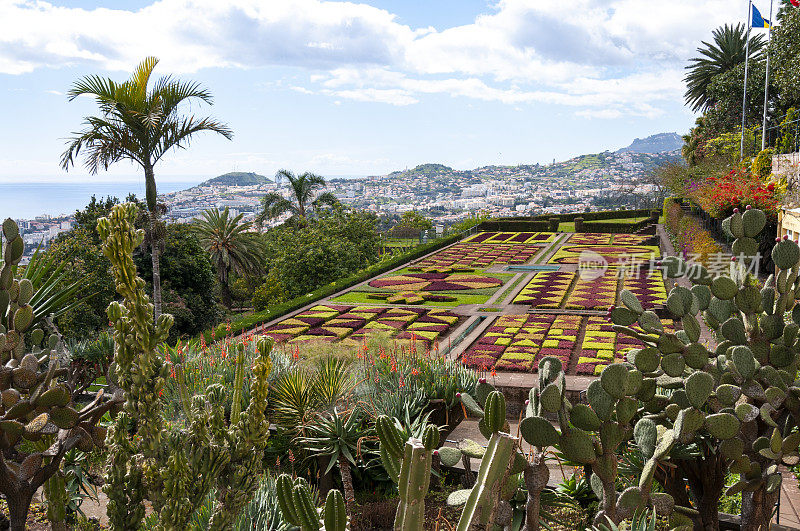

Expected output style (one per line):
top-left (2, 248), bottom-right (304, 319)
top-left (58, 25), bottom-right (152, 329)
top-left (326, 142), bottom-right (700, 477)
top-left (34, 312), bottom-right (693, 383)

top-left (612, 207), bottom-right (800, 529)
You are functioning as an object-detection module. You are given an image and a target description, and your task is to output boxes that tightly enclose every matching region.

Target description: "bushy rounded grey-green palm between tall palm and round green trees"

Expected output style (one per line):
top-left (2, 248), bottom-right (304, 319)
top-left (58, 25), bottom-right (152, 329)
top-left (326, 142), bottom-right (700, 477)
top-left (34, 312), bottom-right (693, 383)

top-left (193, 207), bottom-right (264, 309)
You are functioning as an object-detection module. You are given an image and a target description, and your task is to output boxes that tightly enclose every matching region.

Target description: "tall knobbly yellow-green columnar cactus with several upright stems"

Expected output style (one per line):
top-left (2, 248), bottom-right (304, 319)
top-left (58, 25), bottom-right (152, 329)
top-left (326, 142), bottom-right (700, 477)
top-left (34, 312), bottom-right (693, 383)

top-left (98, 203), bottom-right (272, 530)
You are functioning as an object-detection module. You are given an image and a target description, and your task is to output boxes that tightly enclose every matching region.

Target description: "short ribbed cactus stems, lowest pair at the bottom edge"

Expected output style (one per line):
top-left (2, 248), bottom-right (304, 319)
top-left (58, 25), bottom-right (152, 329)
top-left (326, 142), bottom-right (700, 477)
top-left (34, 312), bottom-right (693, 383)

top-left (275, 474), bottom-right (346, 531)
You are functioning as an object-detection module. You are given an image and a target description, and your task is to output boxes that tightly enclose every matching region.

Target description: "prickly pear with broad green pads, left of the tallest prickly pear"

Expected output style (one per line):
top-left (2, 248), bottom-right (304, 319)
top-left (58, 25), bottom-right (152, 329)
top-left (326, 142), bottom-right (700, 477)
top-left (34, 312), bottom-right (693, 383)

top-left (532, 357), bottom-right (673, 529)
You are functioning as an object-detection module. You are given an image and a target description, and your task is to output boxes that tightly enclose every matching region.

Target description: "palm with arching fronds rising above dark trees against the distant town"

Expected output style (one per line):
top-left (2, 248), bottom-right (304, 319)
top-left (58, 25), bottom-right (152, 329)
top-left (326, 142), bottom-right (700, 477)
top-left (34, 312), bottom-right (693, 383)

top-left (256, 170), bottom-right (339, 226)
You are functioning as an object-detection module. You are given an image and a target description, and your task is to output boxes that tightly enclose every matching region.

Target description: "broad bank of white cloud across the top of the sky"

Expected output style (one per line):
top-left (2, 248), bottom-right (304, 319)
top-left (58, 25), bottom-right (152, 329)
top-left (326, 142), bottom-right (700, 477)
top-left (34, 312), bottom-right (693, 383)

top-left (0, 0), bottom-right (742, 118)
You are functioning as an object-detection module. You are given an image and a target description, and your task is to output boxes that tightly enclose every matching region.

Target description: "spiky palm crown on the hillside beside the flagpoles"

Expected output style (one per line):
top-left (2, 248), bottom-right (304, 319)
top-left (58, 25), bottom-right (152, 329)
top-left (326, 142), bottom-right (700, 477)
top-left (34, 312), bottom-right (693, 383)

top-left (683, 24), bottom-right (765, 112)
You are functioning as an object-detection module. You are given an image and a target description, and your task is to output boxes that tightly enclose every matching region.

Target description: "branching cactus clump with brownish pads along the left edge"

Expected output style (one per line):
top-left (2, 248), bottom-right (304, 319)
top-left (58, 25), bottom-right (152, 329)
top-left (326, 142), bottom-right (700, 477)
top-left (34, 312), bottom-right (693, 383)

top-left (0, 219), bottom-right (122, 531)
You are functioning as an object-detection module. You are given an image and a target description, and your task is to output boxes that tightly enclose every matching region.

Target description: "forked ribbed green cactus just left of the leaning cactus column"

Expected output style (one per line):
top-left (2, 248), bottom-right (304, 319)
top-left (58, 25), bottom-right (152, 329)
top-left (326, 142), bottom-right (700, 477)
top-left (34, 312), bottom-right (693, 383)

top-left (375, 415), bottom-right (439, 531)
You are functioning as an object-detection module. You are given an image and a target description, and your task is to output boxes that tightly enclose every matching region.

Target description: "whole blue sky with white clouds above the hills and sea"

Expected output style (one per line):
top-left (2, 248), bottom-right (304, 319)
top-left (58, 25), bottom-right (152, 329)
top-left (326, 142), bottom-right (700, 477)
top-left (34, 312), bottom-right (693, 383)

top-left (0, 0), bottom-right (769, 182)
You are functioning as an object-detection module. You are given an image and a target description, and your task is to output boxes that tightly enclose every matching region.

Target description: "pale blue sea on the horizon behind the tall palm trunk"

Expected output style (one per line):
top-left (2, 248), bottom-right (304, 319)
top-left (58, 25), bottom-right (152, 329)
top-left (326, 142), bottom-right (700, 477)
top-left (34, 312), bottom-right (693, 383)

top-left (0, 178), bottom-right (201, 219)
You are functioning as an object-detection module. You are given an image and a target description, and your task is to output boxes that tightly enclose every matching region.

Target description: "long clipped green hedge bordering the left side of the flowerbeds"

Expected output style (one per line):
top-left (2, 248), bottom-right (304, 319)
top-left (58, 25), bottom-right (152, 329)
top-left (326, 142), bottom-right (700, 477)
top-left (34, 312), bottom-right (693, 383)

top-left (202, 234), bottom-right (461, 342)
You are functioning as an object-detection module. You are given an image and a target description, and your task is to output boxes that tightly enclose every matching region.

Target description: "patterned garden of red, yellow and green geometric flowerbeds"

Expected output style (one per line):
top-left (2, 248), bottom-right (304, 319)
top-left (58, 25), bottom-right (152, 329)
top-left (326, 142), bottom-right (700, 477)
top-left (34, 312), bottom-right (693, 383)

top-left (257, 227), bottom-right (674, 376)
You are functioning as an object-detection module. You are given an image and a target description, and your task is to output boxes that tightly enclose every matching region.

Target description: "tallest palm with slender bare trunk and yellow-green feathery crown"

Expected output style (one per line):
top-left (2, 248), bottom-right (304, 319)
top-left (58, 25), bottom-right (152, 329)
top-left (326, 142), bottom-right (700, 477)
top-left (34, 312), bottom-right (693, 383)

top-left (61, 57), bottom-right (233, 319)
